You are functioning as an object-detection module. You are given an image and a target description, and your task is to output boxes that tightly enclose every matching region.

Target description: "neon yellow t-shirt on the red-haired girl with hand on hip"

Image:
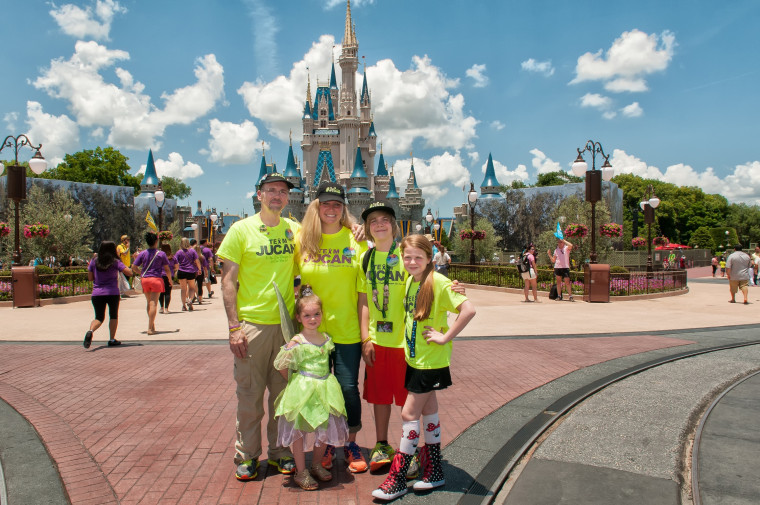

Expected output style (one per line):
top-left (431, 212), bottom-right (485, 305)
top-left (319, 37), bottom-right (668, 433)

top-left (404, 272), bottom-right (467, 370)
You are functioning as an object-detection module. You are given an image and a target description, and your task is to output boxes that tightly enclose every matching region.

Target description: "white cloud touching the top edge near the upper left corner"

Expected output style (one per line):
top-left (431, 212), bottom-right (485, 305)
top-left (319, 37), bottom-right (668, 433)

top-left (50, 0), bottom-right (127, 40)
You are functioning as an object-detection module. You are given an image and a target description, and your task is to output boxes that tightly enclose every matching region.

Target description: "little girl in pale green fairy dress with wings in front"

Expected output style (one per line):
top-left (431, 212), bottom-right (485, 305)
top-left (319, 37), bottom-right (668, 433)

top-left (274, 284), bottom-right (348, 491)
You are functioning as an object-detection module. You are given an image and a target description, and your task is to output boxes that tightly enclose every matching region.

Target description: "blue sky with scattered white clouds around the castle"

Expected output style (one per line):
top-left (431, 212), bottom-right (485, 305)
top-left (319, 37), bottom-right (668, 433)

top-left (0, 0), bottom-right (760, 216)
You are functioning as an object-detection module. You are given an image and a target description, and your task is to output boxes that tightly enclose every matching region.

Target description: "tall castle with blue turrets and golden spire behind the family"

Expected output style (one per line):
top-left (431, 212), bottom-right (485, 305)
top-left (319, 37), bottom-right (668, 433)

top-left (253, 0), bottom-right (425, 224)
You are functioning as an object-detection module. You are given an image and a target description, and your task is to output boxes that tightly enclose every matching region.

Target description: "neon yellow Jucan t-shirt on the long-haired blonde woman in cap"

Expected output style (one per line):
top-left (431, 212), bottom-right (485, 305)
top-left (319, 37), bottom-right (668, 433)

top-left (296, 228), bottom-right (367, 344)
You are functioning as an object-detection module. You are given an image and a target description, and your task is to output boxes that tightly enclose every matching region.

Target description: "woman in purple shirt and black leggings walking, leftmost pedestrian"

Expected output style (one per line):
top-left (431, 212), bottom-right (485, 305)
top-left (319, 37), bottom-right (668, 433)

top-left (82, 241), bottom-right (132, 349)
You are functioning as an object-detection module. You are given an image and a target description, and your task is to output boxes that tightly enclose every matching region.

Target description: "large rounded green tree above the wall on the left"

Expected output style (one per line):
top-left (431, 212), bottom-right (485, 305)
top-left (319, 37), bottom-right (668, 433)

top-left (41, 147), bottom-right (141, 195)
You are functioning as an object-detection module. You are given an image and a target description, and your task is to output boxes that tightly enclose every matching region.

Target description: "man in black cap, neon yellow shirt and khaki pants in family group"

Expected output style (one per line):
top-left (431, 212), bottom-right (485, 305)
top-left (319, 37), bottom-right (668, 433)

top-left (217, 173), bottom-right (300, 481)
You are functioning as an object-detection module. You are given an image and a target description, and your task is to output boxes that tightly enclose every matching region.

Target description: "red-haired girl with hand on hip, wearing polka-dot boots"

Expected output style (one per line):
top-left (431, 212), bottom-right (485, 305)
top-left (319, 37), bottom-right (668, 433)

top-left (372, 235), bottom-right (475, 500)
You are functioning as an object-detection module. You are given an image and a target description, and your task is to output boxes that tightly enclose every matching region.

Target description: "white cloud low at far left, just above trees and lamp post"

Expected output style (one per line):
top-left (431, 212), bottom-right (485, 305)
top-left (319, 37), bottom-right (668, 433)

top-left (26, 101), bottom-right (79, 168)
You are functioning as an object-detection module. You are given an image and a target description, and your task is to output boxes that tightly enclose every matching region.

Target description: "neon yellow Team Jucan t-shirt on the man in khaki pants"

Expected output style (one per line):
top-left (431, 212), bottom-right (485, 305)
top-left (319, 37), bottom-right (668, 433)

top-left (217, 214), bottom-right (300, 324)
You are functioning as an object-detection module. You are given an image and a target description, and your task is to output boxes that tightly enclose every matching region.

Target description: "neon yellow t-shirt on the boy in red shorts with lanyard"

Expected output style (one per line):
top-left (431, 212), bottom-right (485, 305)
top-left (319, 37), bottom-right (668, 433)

top-left (359, 246), bottom-right (406, 349)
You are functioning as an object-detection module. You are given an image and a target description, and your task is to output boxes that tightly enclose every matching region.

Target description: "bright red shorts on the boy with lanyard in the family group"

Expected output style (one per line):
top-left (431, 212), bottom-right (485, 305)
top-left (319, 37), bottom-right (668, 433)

top-left (362, 344), bottom-right (407, 407)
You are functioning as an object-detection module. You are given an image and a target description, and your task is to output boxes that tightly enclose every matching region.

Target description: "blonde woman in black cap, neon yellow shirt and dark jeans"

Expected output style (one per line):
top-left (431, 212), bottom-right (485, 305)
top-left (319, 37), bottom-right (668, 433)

top-left (295, 182), bottom-right (367, 473)
